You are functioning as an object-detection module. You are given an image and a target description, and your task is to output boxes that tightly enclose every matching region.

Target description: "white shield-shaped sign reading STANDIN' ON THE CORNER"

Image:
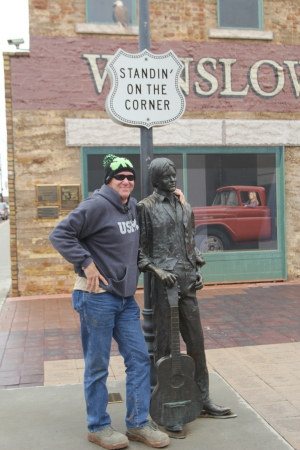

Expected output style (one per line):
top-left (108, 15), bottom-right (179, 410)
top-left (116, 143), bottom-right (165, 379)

top-left (106, 49), bottom-right (185, 128)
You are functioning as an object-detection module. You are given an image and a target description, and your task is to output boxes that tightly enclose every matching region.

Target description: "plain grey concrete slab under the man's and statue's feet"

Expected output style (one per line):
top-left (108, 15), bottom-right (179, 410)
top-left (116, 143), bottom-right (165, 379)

top-left (0, 373), bottom-right (293, 450)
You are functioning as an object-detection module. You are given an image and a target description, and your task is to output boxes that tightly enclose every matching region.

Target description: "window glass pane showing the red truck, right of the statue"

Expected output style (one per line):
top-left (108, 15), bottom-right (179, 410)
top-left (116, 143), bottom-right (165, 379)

top-left (187, 153), bottom-right (277, 253)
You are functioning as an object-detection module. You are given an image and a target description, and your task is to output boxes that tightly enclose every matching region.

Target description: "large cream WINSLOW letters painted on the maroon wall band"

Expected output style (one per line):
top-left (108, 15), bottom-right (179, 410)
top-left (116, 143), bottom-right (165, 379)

top-left (82, 53), bottom-right (300, 98)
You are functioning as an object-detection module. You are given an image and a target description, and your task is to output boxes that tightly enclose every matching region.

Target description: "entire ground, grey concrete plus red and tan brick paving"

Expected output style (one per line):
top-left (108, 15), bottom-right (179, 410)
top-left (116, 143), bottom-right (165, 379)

top-left (0, 283), bottom-right (300, 450)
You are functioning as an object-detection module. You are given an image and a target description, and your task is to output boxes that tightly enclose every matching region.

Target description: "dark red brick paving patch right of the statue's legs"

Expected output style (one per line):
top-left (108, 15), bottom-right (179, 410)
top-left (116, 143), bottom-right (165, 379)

top-left (198, 283), bottom-right (300, 349)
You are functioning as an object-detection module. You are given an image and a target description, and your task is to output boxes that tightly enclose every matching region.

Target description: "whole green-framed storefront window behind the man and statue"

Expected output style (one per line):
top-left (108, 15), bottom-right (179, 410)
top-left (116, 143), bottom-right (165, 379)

top-left (82, 147), bottom-right (286, 283)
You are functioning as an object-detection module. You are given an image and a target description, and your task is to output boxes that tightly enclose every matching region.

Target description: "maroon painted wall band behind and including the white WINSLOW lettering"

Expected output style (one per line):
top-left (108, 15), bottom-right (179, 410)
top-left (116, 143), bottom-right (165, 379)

top-left (11, 36), bottom-right (300, 114)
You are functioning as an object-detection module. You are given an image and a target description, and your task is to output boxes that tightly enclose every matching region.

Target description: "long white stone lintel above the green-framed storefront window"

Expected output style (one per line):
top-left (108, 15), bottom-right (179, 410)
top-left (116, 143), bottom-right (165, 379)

top-left (65, 119), bottom-right (300, 147)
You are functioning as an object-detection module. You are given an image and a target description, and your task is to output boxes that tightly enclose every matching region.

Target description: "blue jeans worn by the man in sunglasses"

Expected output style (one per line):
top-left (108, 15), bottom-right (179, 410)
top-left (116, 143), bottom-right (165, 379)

top-left (72, 290), bottom-right (150, 432)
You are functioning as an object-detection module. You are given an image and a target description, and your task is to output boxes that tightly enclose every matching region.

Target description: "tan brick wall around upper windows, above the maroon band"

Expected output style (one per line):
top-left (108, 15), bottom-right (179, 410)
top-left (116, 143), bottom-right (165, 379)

top-left (29, 0), bottom-right (300, 44)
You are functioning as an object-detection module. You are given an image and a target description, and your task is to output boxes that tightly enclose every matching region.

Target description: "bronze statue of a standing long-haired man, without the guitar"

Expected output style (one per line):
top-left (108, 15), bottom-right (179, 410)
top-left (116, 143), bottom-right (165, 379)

top-left (137, 158), bottom-right (230, 431)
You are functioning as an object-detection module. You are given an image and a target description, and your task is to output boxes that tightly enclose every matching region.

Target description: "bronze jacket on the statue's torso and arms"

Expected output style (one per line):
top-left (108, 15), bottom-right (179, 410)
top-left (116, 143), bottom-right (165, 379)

top-left (137, 192), bottom-right (204, 272)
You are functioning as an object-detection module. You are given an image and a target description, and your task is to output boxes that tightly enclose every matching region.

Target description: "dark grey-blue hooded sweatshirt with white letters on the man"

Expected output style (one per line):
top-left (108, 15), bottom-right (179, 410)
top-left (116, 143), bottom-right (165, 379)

top-left (49, 184), bottom-right (139, 297)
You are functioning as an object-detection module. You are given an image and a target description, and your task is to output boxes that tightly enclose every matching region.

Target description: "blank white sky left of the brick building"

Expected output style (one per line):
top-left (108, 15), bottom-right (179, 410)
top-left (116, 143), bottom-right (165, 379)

top-left (0, 0), bottom-right (29, 196)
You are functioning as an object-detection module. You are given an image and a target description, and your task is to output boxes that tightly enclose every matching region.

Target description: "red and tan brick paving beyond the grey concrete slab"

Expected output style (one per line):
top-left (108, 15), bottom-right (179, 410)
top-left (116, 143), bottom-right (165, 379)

top-left (0, 283), bottom-right (300, 450)
